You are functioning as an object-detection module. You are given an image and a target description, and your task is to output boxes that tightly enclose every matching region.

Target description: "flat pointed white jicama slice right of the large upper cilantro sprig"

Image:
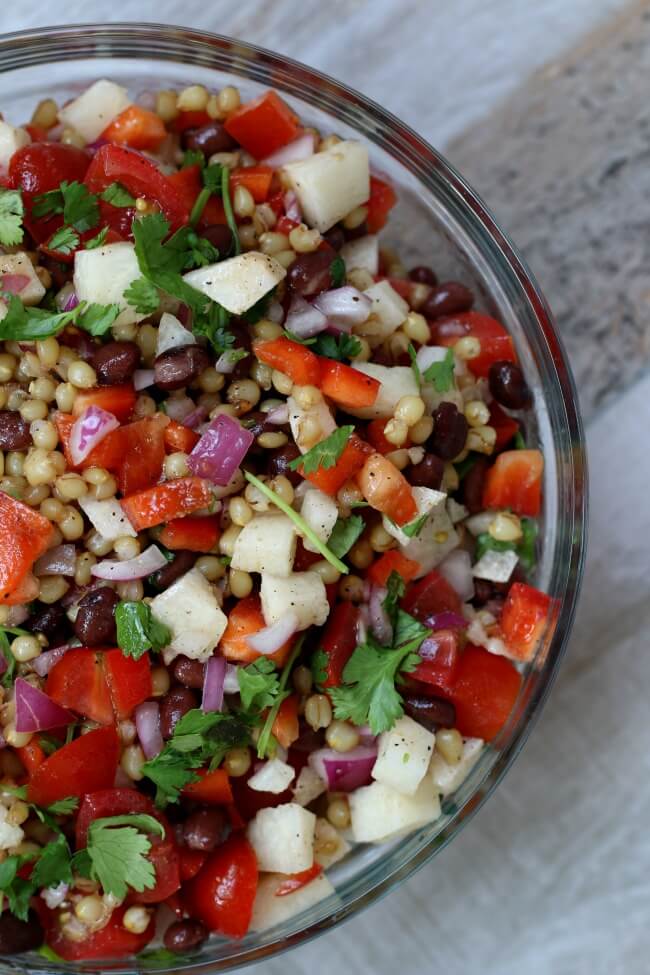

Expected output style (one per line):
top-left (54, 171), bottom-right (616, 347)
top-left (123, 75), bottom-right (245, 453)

top-left (183, 251), bottom-right (287, 315)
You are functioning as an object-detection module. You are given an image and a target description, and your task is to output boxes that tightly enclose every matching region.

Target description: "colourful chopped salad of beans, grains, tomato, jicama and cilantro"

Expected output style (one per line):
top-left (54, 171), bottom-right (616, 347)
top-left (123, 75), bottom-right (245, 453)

top-left (0, 80), bottom-right (551, 961)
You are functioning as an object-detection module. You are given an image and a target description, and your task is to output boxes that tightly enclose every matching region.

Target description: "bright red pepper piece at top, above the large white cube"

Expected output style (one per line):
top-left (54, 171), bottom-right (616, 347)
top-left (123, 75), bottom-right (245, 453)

top-left (224, 91), bottom-right (300, 159)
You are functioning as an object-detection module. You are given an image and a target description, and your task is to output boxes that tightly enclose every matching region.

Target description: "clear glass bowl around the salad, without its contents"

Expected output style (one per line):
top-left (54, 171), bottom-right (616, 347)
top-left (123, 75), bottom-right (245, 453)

top-left (0, 24), bottom-right (586, 975)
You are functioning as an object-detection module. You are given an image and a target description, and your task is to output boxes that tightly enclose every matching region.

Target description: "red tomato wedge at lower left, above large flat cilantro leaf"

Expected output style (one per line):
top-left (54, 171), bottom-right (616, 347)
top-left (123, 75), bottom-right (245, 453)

top-left (27, 726), bottom-right (120, 806)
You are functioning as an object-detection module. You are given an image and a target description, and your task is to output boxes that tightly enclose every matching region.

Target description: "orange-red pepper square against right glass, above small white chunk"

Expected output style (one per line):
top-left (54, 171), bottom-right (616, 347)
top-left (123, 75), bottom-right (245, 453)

top-left (483, 450), bottom-right (544, 518)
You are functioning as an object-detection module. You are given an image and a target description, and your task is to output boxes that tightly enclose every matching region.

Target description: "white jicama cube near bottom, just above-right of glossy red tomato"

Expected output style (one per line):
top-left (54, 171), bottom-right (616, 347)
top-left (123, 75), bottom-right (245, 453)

top-left (248, 802), bottom-right (316, 873)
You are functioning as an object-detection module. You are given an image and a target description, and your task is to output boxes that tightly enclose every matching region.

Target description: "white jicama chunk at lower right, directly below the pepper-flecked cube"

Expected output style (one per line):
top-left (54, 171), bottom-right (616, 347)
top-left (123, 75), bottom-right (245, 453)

top-left (349, 776), bottom-right (440, 843)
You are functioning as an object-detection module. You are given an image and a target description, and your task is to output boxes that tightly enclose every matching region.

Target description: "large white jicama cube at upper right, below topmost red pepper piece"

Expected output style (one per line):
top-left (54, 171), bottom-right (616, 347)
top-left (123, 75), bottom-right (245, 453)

top-left (282, 141), bottom-right (370, 233)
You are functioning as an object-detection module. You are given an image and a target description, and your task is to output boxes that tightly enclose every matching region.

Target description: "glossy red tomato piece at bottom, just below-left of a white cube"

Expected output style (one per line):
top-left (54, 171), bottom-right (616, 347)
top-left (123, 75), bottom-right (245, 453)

top-left (184, 833), bottom-right (258, 938)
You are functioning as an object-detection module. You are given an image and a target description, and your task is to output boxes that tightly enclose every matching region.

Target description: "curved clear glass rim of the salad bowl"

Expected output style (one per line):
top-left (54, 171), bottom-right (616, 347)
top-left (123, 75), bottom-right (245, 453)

top-left (0, 24), bottom-right (586, 975)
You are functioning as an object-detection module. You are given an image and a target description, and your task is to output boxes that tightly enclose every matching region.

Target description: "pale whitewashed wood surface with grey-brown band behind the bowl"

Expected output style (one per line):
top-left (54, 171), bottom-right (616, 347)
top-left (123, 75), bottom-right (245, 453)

top-left (0, 0), bottom-right (650, 975)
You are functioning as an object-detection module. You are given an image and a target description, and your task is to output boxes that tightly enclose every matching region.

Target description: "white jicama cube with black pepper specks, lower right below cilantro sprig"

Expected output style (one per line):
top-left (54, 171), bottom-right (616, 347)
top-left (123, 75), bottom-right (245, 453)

top-left (372, 715), bottom-right (436, 796)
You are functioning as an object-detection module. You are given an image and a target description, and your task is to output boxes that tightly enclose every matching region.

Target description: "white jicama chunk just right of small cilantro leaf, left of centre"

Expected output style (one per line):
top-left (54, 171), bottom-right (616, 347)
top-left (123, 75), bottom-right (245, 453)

top-left (151, 569), bottom-right (228, 664)
